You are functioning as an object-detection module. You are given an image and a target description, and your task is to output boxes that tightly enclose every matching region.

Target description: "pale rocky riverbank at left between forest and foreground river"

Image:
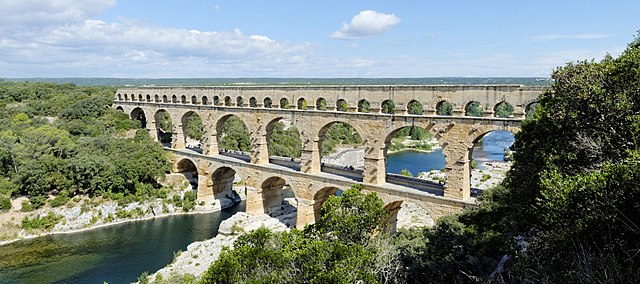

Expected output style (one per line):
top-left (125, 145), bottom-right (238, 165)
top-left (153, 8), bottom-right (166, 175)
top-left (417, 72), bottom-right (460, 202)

top-left (0, 173), bottom-right (246, 246)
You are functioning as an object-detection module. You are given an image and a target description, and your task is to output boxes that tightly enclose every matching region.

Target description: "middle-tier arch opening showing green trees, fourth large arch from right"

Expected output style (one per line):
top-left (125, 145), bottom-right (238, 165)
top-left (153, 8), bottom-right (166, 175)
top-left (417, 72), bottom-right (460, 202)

top-left (266, 118), bottom-right (302, 171)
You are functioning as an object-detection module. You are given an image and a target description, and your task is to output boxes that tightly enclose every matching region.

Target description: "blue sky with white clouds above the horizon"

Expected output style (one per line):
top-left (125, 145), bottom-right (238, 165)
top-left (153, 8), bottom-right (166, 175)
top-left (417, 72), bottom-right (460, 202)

top-left (0, 0), bottom-right (640, 78)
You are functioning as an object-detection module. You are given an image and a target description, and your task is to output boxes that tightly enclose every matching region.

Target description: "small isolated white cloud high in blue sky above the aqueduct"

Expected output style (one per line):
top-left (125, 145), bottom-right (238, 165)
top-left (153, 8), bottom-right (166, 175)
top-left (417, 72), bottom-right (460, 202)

top-left (331, 10), bottom-right (400, 39)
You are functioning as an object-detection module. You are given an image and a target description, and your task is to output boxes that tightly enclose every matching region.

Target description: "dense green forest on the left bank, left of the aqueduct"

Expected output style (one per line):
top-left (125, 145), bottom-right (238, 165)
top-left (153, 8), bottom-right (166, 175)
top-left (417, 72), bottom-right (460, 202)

top-left (0, 81), bottom-right (171, 210)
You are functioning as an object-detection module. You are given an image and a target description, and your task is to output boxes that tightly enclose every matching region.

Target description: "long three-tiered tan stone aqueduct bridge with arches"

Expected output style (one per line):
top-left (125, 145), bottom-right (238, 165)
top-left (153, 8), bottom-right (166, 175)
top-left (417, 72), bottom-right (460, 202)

top-left (114, 85), bottom-right (544, 227)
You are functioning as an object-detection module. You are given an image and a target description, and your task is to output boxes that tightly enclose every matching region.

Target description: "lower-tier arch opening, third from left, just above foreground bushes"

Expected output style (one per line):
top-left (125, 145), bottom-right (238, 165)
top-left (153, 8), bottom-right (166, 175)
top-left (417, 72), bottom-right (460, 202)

top-left (261, 177), bottom-right (298, 228)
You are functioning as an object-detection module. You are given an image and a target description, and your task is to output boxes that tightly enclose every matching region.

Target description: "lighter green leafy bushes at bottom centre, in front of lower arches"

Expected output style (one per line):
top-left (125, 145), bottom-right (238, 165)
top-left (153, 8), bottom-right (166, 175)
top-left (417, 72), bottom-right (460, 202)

top-left (201, 187), bottom-right (396, 283)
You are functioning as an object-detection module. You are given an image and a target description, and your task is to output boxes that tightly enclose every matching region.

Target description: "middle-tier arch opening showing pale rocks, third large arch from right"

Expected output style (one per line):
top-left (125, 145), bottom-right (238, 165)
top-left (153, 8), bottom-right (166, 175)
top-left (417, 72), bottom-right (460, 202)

top-left (318, 121), bottom-right (364, 181)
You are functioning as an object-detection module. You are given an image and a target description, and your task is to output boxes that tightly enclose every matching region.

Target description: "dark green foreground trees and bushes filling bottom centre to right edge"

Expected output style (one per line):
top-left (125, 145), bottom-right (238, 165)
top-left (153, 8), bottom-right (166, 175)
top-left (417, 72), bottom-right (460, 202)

top-left (195, 36), bottom-right (640, 283)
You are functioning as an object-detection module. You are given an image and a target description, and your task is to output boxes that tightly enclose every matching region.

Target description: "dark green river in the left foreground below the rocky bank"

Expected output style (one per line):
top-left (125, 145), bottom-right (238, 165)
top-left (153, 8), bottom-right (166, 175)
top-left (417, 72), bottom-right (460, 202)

top-left (0, 203), bottom-right (244, 284)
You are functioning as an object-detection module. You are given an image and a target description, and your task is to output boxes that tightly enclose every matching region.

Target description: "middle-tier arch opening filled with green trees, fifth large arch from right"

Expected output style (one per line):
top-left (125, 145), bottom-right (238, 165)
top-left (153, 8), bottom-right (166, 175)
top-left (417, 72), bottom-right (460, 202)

top-left (216, 114), bottom-right (251, 161)
